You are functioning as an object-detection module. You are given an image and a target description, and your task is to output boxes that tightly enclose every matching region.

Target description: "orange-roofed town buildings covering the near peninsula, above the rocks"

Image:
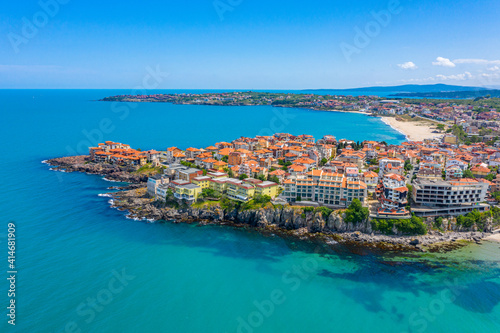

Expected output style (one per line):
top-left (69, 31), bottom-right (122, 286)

top-left (89, 127), bottom-right (500, 233)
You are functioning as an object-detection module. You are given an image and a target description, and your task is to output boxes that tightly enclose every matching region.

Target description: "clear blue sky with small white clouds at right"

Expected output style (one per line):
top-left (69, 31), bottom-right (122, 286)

top-left (0, 0), bottom-right (500, 89)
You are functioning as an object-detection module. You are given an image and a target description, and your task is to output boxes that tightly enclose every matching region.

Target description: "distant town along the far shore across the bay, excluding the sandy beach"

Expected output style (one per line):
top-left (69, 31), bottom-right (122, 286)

top-left (102, 91), bottom-right (500, 139)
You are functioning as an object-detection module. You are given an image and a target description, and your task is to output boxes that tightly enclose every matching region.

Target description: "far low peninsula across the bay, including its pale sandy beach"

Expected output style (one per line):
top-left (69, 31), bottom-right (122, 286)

top-left (101, 91), bottom-right (500, 142)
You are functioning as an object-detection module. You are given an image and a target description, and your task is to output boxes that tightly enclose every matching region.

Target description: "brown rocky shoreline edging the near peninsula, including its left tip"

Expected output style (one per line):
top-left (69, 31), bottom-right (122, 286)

top-left (46, 156), bottom-right (498, 252)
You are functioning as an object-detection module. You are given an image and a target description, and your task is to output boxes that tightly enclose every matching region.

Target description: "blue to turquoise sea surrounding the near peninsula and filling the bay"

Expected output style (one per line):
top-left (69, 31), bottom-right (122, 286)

top-left (0, 90), bottom-right (500, 333)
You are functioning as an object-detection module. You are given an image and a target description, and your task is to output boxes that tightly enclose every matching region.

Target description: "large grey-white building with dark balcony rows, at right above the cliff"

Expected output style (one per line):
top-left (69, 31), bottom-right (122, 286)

top-left (412, 178), bottom-right (489, 216)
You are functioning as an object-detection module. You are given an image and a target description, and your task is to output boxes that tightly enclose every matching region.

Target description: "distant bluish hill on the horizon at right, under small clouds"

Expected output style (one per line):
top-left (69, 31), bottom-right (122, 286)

top-left (305, 83), bottom-right (487, 93)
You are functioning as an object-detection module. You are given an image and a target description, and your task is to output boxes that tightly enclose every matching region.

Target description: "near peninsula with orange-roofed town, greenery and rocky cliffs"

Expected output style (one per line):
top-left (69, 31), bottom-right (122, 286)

top-left (47, 133), bottom-right (500, 251)
